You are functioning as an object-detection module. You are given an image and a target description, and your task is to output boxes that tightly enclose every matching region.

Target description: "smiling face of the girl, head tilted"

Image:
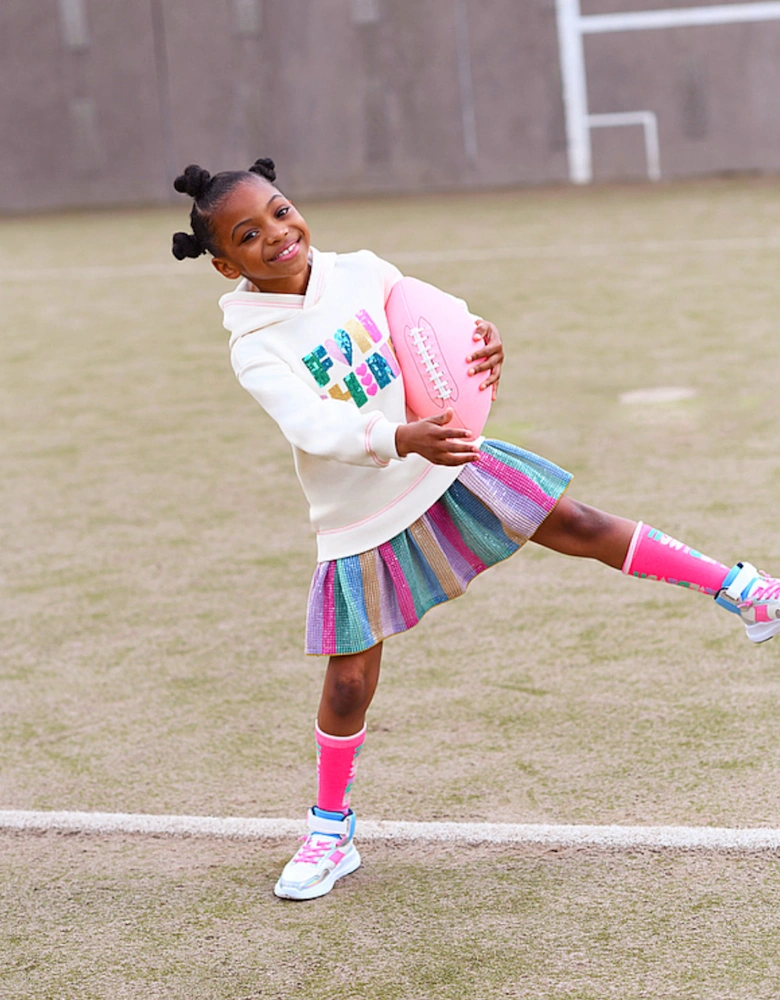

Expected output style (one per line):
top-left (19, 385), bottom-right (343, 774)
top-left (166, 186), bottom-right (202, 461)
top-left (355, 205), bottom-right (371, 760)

top-left (211, 177), bottom-right (311, 295)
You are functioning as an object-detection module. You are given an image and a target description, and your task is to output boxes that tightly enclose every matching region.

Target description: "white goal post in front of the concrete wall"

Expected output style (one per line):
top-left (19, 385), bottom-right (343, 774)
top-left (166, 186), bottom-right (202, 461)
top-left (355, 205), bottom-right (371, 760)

top-left (556, 0), bottom-right (780, 184)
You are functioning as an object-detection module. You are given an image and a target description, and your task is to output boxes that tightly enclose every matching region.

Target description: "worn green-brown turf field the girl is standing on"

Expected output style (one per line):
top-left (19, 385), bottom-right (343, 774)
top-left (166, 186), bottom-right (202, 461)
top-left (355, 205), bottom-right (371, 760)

top-left (0, 181), bottom-right (780, 1000)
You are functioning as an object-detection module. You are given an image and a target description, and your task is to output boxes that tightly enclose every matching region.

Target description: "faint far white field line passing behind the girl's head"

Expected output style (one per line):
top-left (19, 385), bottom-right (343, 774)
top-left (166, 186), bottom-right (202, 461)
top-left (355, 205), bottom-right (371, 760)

top-left (0, 235), bottom-right (780, 284)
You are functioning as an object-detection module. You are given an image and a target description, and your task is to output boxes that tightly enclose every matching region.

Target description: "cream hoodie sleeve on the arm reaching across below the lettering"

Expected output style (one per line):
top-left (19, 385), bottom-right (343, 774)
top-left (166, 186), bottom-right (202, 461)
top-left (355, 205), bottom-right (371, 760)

top-left (232, 351), bottom-right (403, 467)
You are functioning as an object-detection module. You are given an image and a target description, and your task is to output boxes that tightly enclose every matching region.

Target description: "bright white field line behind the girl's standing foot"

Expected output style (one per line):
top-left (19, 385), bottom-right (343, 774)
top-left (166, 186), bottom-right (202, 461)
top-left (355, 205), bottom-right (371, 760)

top-left (0, 810), bottom-right (780, 851)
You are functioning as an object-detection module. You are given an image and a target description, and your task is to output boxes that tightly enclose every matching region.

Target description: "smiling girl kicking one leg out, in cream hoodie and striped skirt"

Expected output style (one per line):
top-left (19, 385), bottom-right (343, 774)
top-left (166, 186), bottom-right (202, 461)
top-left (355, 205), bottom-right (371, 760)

top-left (173, 160), bottom-right (780, 899)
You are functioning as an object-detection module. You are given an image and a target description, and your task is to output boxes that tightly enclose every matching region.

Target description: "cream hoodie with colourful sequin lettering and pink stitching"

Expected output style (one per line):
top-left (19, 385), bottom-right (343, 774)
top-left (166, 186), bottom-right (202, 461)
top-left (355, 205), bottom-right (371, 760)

top-left (219, 248), bottom-right (461, 561)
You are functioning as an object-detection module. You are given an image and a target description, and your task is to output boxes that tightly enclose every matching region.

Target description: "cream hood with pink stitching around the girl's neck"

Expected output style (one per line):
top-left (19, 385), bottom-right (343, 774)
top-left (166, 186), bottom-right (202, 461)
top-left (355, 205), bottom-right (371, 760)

top-left (219, 247), bottom-right (336, 348)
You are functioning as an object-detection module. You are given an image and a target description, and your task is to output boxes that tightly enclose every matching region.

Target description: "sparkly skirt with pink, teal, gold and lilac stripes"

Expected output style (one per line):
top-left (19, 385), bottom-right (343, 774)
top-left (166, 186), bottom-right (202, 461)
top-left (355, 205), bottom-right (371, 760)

top-left (306, 441), bottom-right (571, 655)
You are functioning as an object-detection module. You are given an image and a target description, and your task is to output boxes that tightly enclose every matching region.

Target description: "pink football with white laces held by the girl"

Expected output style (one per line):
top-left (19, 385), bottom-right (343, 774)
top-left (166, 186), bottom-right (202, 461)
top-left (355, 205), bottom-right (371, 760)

top-left (385, 278), bottom-right (491, 435)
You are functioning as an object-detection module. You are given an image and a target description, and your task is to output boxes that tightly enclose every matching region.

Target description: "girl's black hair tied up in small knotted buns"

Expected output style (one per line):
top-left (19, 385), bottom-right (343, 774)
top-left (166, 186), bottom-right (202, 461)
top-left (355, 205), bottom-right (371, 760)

top-left (172, 159), bottom-right (276, 260)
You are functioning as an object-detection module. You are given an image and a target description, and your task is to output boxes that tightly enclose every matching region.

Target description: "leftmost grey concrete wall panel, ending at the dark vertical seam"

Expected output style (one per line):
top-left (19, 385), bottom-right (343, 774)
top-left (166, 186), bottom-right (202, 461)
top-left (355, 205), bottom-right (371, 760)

top-left (0, 0), bottom-right (164, 210)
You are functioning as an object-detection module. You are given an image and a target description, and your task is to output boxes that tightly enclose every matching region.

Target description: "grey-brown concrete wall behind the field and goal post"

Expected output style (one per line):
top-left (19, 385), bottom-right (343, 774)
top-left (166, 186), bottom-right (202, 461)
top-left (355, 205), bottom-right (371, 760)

top-left (0, 0), bottom-right (780, 211)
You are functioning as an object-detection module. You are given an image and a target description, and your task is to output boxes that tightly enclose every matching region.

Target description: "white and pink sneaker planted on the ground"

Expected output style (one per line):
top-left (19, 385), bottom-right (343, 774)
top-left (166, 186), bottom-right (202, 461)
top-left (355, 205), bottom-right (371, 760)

top-left (274, 809), bottom-right (360, 899)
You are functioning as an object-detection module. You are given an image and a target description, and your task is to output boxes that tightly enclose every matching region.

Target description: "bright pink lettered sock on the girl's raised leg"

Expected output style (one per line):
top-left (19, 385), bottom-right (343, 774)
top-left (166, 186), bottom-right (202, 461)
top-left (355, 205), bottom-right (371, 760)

top-left (623, 521), bottom-right (729, 594)
